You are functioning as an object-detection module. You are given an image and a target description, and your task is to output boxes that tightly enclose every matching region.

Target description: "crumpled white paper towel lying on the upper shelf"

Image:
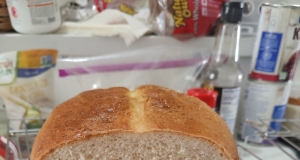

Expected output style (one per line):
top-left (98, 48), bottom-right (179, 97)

top-left (57, 9), bottom-right (150, 45)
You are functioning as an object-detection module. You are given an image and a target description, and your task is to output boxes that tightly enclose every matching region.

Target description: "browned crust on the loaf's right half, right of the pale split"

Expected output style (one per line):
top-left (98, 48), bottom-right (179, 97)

top-left (136, 86), bottom-right (238, 159)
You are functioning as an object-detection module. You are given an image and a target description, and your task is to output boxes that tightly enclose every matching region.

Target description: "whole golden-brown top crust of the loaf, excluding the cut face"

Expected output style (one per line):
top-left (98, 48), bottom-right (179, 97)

top-left (31, 86), bottom-right (238, 160)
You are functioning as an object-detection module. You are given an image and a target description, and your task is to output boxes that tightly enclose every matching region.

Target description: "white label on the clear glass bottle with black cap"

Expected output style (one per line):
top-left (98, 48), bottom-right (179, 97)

top-left (215, 87), bottom-right (241, 134)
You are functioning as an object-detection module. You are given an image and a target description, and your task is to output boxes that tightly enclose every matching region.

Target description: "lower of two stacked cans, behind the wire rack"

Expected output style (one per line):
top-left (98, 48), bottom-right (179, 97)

top-left (238, 78), bottom-right (292, 144)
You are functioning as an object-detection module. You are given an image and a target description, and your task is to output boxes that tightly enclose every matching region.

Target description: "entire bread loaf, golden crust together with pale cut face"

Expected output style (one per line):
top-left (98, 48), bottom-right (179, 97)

top-left (31, 86), bottom-right (238, 160)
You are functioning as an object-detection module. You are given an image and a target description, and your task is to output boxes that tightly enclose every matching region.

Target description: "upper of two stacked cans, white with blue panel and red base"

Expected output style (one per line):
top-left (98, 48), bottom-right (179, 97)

top-left (250, 4), bottom-right (300, 82)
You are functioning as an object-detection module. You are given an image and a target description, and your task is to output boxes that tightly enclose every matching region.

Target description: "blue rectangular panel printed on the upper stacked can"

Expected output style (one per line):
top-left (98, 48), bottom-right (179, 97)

top-left (255, 32), bottom-right (283, 73)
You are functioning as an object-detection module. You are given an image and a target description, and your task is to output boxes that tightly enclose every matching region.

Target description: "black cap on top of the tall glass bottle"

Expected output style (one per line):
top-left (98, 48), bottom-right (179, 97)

top-left (221, 2), bottom-right (244, 23)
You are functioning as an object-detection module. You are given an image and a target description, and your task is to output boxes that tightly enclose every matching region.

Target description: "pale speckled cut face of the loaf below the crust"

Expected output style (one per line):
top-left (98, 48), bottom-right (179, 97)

top-left (45, 132), bottom-right (228, 160)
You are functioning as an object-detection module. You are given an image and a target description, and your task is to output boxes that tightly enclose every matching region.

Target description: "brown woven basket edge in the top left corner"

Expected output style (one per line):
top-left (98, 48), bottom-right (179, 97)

top-left (0, 0), bottom-right (12, 32)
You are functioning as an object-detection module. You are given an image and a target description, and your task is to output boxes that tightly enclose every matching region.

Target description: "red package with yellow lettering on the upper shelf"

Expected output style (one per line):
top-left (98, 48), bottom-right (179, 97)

top-left (149, 0), bottom-right (228, 38)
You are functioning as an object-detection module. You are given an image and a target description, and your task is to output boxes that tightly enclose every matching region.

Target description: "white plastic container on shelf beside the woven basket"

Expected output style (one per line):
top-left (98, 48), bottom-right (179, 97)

top-left (6, 0), bottom-right (62, 34)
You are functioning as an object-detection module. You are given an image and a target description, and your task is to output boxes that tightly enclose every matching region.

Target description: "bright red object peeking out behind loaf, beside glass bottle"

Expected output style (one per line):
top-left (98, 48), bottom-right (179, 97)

top-left (187, 88), bottom-right (218, 109)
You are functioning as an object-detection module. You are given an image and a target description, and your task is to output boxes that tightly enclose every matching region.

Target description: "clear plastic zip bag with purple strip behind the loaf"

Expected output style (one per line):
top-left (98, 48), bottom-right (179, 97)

top-left (55, 46), bottom-right (208, 104)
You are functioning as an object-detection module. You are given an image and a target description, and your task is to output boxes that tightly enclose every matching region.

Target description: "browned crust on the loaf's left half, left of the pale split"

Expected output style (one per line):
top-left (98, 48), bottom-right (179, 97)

top-left (31, 88), bottom-right (131, 160)
